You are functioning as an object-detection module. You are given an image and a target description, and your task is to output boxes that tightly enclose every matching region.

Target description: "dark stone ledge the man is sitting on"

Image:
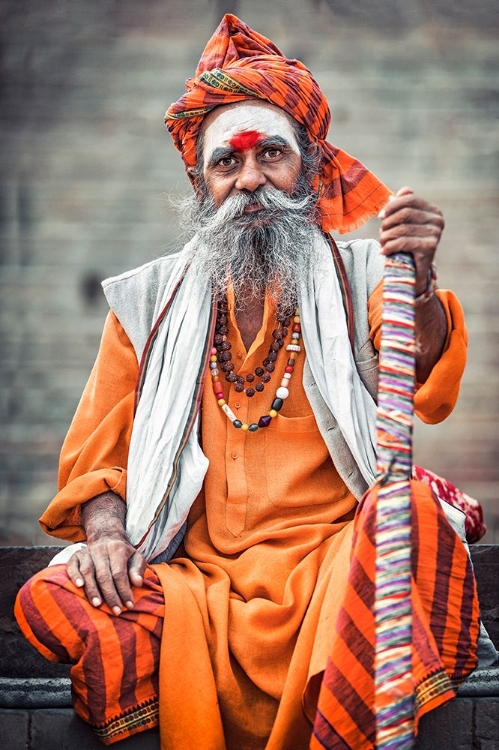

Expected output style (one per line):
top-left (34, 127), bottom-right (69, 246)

top-left (0, 544), bottom-right (499, 750)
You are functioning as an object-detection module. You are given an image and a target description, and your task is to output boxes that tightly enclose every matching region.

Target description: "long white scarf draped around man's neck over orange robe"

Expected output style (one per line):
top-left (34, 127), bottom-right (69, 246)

top-left (126, 232), bottom-right (376, 561)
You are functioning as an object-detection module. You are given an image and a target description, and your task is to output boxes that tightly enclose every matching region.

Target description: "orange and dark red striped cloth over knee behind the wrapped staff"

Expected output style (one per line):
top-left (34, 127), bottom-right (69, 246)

top-left (310, 481), bottom-right (479, 750)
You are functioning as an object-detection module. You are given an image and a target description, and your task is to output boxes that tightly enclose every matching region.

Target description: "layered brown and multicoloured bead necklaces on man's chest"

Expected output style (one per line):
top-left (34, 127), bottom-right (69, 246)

top-left (210, 297), bottom-right (301, 432)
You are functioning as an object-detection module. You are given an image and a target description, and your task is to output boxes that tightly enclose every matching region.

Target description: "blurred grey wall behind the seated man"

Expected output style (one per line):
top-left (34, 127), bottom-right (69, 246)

top-left (0, 0), bottom-right (499, 545)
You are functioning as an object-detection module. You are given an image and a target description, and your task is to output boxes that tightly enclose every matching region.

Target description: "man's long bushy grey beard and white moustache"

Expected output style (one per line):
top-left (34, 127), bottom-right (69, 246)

top-left (177, 180), bottom-right (318, 310)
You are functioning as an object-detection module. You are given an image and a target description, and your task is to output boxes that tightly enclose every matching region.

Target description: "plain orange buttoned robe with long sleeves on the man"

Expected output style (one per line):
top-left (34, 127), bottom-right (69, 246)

top-left (21, 286), bottom-right (477, 750)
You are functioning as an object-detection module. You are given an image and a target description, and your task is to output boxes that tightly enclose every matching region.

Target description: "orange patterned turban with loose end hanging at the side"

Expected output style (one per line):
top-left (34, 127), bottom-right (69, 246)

top-left (165, 14), bottom-right (391, 232)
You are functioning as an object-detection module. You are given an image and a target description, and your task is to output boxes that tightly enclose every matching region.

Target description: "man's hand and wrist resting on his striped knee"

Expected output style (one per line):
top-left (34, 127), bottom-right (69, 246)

top-left (67, 492), bottom-right (147, 615)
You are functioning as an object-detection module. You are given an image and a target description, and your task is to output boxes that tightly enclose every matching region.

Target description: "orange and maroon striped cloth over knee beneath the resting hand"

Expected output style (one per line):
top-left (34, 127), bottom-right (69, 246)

top-left (15, 565), bottom-right (165, 745)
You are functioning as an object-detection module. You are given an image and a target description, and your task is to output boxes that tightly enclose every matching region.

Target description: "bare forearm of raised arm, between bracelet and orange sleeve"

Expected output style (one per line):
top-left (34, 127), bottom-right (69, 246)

top-left (415, 294), bottom-right (447, 383)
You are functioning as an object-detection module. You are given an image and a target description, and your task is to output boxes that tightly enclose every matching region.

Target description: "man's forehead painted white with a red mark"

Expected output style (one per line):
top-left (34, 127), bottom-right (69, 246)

top-left (203, 101), bottom-right (300, 165)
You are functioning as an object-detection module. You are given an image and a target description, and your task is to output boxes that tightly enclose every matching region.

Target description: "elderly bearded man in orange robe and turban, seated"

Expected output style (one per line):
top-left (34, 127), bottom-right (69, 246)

top-left (16, 15), bottom-right (484, 750)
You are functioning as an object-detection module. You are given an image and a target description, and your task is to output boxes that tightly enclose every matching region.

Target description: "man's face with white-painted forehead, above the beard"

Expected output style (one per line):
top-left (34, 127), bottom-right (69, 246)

top-left (198, 101), bottom-right (301, 213)
